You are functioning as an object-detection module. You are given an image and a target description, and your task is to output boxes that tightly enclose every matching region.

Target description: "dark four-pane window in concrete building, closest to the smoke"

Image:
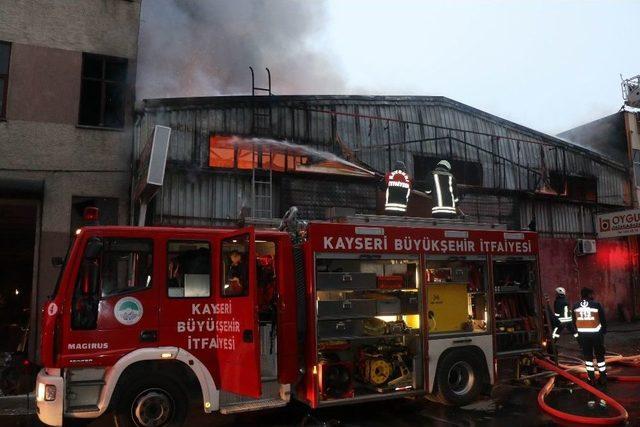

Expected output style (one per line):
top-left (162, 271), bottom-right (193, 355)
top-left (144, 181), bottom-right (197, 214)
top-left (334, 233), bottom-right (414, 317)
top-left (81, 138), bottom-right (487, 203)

top-left (78, 53), bottom-right (127, 128)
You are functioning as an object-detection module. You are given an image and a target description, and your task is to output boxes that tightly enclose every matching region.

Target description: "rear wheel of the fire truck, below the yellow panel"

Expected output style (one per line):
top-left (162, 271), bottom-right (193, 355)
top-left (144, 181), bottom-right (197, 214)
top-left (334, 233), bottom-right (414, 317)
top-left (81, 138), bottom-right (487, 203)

top-left (435, 350), bottom-right (484, 406)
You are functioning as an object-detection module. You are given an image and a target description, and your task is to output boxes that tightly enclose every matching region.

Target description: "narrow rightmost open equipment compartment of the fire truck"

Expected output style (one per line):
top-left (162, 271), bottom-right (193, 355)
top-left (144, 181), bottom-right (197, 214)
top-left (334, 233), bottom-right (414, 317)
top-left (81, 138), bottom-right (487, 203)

top-left (494, 260), bottom-right (541, 355)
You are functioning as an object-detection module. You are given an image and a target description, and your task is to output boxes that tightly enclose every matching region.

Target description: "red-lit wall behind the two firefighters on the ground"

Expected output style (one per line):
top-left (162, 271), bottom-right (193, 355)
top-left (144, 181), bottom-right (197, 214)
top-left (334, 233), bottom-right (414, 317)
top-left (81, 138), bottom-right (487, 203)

top-left (540, 238), bottom-right (632, 319)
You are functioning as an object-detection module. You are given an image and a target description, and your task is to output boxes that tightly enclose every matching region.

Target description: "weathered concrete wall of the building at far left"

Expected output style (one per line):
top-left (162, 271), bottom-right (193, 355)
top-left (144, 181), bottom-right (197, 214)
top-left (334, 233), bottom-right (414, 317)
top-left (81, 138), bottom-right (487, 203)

top-left (0, 0), bottom-right (141, 360)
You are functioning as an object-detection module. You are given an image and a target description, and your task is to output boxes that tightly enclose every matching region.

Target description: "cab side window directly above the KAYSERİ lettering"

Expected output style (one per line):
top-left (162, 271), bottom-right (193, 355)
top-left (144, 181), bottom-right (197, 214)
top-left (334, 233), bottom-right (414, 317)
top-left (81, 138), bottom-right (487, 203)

top-left (167, 241), bottom-right (211, 298)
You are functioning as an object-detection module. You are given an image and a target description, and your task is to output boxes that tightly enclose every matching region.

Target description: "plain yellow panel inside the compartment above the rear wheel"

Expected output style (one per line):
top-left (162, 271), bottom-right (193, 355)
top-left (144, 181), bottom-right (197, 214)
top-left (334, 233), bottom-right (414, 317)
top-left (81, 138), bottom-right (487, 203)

top-left (427, 283), bottom-right (469, 333)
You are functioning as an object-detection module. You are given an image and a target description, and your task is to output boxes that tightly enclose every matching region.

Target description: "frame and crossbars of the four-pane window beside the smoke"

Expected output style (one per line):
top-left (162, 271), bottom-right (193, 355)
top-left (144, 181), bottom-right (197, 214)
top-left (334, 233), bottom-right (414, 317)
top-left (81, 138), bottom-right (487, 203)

top-left (77, 52), bottom-right (129, 130)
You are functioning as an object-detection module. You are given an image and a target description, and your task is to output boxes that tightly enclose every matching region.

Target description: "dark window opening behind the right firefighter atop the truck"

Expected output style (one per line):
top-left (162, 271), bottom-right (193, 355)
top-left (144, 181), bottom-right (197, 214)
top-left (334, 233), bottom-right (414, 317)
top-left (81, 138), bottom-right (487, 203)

top-left (413, 156), bottom-right (482, 191)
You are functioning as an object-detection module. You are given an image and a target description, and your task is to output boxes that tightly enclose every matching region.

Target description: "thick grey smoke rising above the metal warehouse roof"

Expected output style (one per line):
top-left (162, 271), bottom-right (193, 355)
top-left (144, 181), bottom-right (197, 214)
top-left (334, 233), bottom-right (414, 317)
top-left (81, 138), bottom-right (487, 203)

top-left (137, 0), bottom-right (343, 99)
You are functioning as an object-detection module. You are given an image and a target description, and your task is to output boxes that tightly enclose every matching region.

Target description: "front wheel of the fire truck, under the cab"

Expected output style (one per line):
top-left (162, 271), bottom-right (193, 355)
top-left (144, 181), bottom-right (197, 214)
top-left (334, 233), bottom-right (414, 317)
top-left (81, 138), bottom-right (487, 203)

top-left (114, 375), bottom-right (188, 427)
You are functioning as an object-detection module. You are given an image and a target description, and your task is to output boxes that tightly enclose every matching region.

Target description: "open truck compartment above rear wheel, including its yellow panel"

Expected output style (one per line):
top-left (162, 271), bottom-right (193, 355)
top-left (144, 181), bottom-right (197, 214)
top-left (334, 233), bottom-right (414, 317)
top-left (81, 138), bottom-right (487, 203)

top-left (425, 259), bottom-right (489, 335)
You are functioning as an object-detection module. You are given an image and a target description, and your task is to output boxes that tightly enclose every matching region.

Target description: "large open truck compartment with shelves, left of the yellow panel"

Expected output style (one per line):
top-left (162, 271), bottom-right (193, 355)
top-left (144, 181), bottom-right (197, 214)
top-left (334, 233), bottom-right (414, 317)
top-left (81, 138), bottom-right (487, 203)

top-left (316, 258), bottom-right (423, 400)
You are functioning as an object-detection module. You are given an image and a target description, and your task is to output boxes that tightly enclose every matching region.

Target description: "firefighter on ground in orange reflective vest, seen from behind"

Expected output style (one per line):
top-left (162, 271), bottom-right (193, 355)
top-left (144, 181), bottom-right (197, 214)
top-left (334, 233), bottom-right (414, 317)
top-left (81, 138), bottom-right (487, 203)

top-left (573, 288), bottom-right (607, 392)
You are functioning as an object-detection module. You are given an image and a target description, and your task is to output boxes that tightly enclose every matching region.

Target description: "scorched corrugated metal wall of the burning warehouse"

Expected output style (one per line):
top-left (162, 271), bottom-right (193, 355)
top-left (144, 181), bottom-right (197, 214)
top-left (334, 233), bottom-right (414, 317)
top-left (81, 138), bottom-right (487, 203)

top-left (136, 96), bottom-right (628, 234)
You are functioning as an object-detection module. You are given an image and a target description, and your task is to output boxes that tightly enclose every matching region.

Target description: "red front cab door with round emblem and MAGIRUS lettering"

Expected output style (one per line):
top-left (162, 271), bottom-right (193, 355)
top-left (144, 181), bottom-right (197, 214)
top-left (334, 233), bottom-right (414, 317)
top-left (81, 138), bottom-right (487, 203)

top-left (61, 236), bottom-right (157, 366)
